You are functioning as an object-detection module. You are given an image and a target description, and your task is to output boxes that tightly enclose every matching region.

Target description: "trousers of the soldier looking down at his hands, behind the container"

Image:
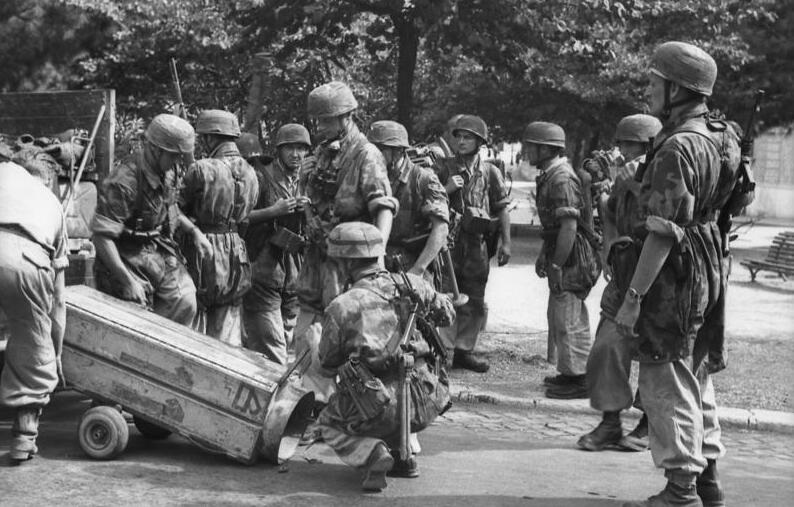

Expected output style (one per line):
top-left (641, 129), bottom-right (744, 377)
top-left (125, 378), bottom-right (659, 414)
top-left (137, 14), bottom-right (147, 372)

top-left (243, 283), bottom-right (298, 364)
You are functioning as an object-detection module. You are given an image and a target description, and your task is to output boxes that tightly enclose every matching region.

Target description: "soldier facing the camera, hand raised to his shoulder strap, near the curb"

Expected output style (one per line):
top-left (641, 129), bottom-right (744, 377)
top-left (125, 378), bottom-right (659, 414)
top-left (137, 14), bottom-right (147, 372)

top-left (436, 115), bottom-right (511, 373)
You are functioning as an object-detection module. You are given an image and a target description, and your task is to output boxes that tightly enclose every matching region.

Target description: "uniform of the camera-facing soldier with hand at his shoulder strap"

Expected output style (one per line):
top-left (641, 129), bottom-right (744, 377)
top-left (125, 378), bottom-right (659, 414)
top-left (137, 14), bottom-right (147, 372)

top-left (436, 156), bottom-right (510, 351)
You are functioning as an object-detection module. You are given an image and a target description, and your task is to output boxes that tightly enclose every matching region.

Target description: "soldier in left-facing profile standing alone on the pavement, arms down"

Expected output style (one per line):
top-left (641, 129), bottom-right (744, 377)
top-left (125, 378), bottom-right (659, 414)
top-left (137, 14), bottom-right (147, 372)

top-left (523, 121), bottom-right (601, 399)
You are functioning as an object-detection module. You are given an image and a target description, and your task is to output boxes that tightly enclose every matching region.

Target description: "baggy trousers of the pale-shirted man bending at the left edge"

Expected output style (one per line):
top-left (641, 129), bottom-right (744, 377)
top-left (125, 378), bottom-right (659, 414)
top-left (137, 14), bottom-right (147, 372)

top-left (0, 231), bottom-right (60, 407)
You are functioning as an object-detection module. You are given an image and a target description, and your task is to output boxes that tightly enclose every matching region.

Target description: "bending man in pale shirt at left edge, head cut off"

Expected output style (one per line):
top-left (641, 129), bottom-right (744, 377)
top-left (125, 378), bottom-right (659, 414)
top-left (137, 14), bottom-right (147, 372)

top-left (0, 156), bottom-right (69, 464)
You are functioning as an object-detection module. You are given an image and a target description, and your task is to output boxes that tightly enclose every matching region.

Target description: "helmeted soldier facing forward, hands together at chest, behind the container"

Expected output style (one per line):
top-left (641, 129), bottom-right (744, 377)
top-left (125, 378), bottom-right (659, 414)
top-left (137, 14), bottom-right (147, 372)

top-left (243, 123), bottom-right (311, 364)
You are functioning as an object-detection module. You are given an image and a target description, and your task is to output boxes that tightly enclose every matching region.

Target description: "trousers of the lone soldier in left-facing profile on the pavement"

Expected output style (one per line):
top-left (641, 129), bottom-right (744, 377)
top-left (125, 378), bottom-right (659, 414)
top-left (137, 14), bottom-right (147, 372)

top-left (546, 291), bottom-right (593, 376)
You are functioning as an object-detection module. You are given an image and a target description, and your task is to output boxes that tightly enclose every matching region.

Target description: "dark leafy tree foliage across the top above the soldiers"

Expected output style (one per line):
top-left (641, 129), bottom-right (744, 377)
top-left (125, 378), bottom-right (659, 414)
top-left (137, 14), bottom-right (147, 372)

top-left (0, 0), bottom-right (794, 155)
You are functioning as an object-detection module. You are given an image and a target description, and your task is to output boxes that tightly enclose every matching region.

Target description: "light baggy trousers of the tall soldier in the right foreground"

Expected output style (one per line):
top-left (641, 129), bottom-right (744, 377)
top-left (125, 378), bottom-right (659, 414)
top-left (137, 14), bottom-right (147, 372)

top-left (639, 358), bottom-right (725, 478)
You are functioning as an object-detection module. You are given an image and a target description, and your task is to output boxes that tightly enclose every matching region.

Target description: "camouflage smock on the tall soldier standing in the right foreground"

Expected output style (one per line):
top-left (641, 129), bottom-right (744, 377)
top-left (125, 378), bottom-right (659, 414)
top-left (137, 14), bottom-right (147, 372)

top-left (636, 104), bottom-right (740, 371)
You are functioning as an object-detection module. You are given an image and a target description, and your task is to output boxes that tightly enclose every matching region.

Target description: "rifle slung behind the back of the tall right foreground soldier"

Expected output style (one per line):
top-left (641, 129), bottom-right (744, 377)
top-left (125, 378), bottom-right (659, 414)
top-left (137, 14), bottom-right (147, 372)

top-left (717, 90), bottom-right (765, 257)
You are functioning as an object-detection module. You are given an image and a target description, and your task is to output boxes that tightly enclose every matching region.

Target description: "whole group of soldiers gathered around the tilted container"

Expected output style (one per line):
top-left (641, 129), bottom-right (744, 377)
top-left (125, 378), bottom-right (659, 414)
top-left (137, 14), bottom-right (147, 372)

top-left (0, 42), bottom-right (739, 507)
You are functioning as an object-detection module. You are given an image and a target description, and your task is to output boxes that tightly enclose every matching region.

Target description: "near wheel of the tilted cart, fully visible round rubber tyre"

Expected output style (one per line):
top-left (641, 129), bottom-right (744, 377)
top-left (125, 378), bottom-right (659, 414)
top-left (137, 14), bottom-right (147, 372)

top-left (77, 405), bottom-right (130, 459)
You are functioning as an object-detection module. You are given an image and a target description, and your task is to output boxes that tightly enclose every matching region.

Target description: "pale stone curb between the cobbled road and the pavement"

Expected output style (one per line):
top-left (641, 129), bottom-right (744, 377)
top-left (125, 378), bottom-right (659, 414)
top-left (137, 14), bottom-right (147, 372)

top-left (450, 386), bottom-right (794, 434)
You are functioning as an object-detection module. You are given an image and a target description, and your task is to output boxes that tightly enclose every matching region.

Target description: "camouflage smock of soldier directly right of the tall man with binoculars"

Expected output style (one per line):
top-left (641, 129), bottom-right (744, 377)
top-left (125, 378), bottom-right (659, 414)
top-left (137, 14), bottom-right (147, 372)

top-left (386, 157), bottom-right (449, 282)
